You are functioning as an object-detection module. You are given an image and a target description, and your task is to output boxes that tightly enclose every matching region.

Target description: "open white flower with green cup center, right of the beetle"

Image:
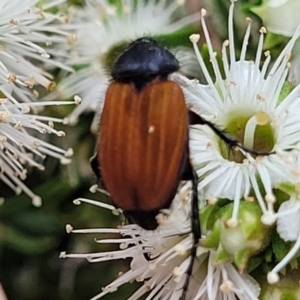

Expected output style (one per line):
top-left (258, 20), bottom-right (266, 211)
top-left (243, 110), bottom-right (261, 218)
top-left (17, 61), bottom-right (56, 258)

top-left (174, 1), bottom-right (300, 225)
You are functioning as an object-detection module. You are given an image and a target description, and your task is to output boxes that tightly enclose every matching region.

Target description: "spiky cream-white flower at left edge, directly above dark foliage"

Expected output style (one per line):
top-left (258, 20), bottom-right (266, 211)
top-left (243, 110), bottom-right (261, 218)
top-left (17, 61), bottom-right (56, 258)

top-left (0, 98), bottom-right (73, 206)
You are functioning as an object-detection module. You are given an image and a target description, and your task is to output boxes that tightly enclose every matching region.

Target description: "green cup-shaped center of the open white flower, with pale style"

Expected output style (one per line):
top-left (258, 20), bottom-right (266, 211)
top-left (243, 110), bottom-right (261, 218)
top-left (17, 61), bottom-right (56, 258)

top-left (219, 111), bottom-right (275, 163)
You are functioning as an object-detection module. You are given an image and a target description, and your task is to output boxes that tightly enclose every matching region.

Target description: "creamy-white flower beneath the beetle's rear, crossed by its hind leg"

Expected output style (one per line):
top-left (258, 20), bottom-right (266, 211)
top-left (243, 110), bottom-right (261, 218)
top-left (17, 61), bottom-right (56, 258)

top-left (61, 184), bottom-right (260, 300)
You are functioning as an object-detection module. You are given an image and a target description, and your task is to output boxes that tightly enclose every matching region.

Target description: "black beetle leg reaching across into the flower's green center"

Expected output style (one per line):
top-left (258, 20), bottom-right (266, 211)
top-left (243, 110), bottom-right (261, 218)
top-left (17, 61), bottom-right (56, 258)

top-left (189, 111), bottom-right (280, 156)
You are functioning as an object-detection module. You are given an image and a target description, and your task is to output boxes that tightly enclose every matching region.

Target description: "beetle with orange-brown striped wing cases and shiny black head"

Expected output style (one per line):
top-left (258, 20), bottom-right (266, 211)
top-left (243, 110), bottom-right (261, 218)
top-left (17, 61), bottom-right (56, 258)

top-left (91, 37), bottom-right (272, 299)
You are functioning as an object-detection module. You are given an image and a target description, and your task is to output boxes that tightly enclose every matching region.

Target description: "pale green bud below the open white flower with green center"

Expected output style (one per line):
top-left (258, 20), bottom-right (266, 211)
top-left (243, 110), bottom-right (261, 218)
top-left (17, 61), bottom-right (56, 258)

top-left (203, 201), bottom-right (270, 272)
